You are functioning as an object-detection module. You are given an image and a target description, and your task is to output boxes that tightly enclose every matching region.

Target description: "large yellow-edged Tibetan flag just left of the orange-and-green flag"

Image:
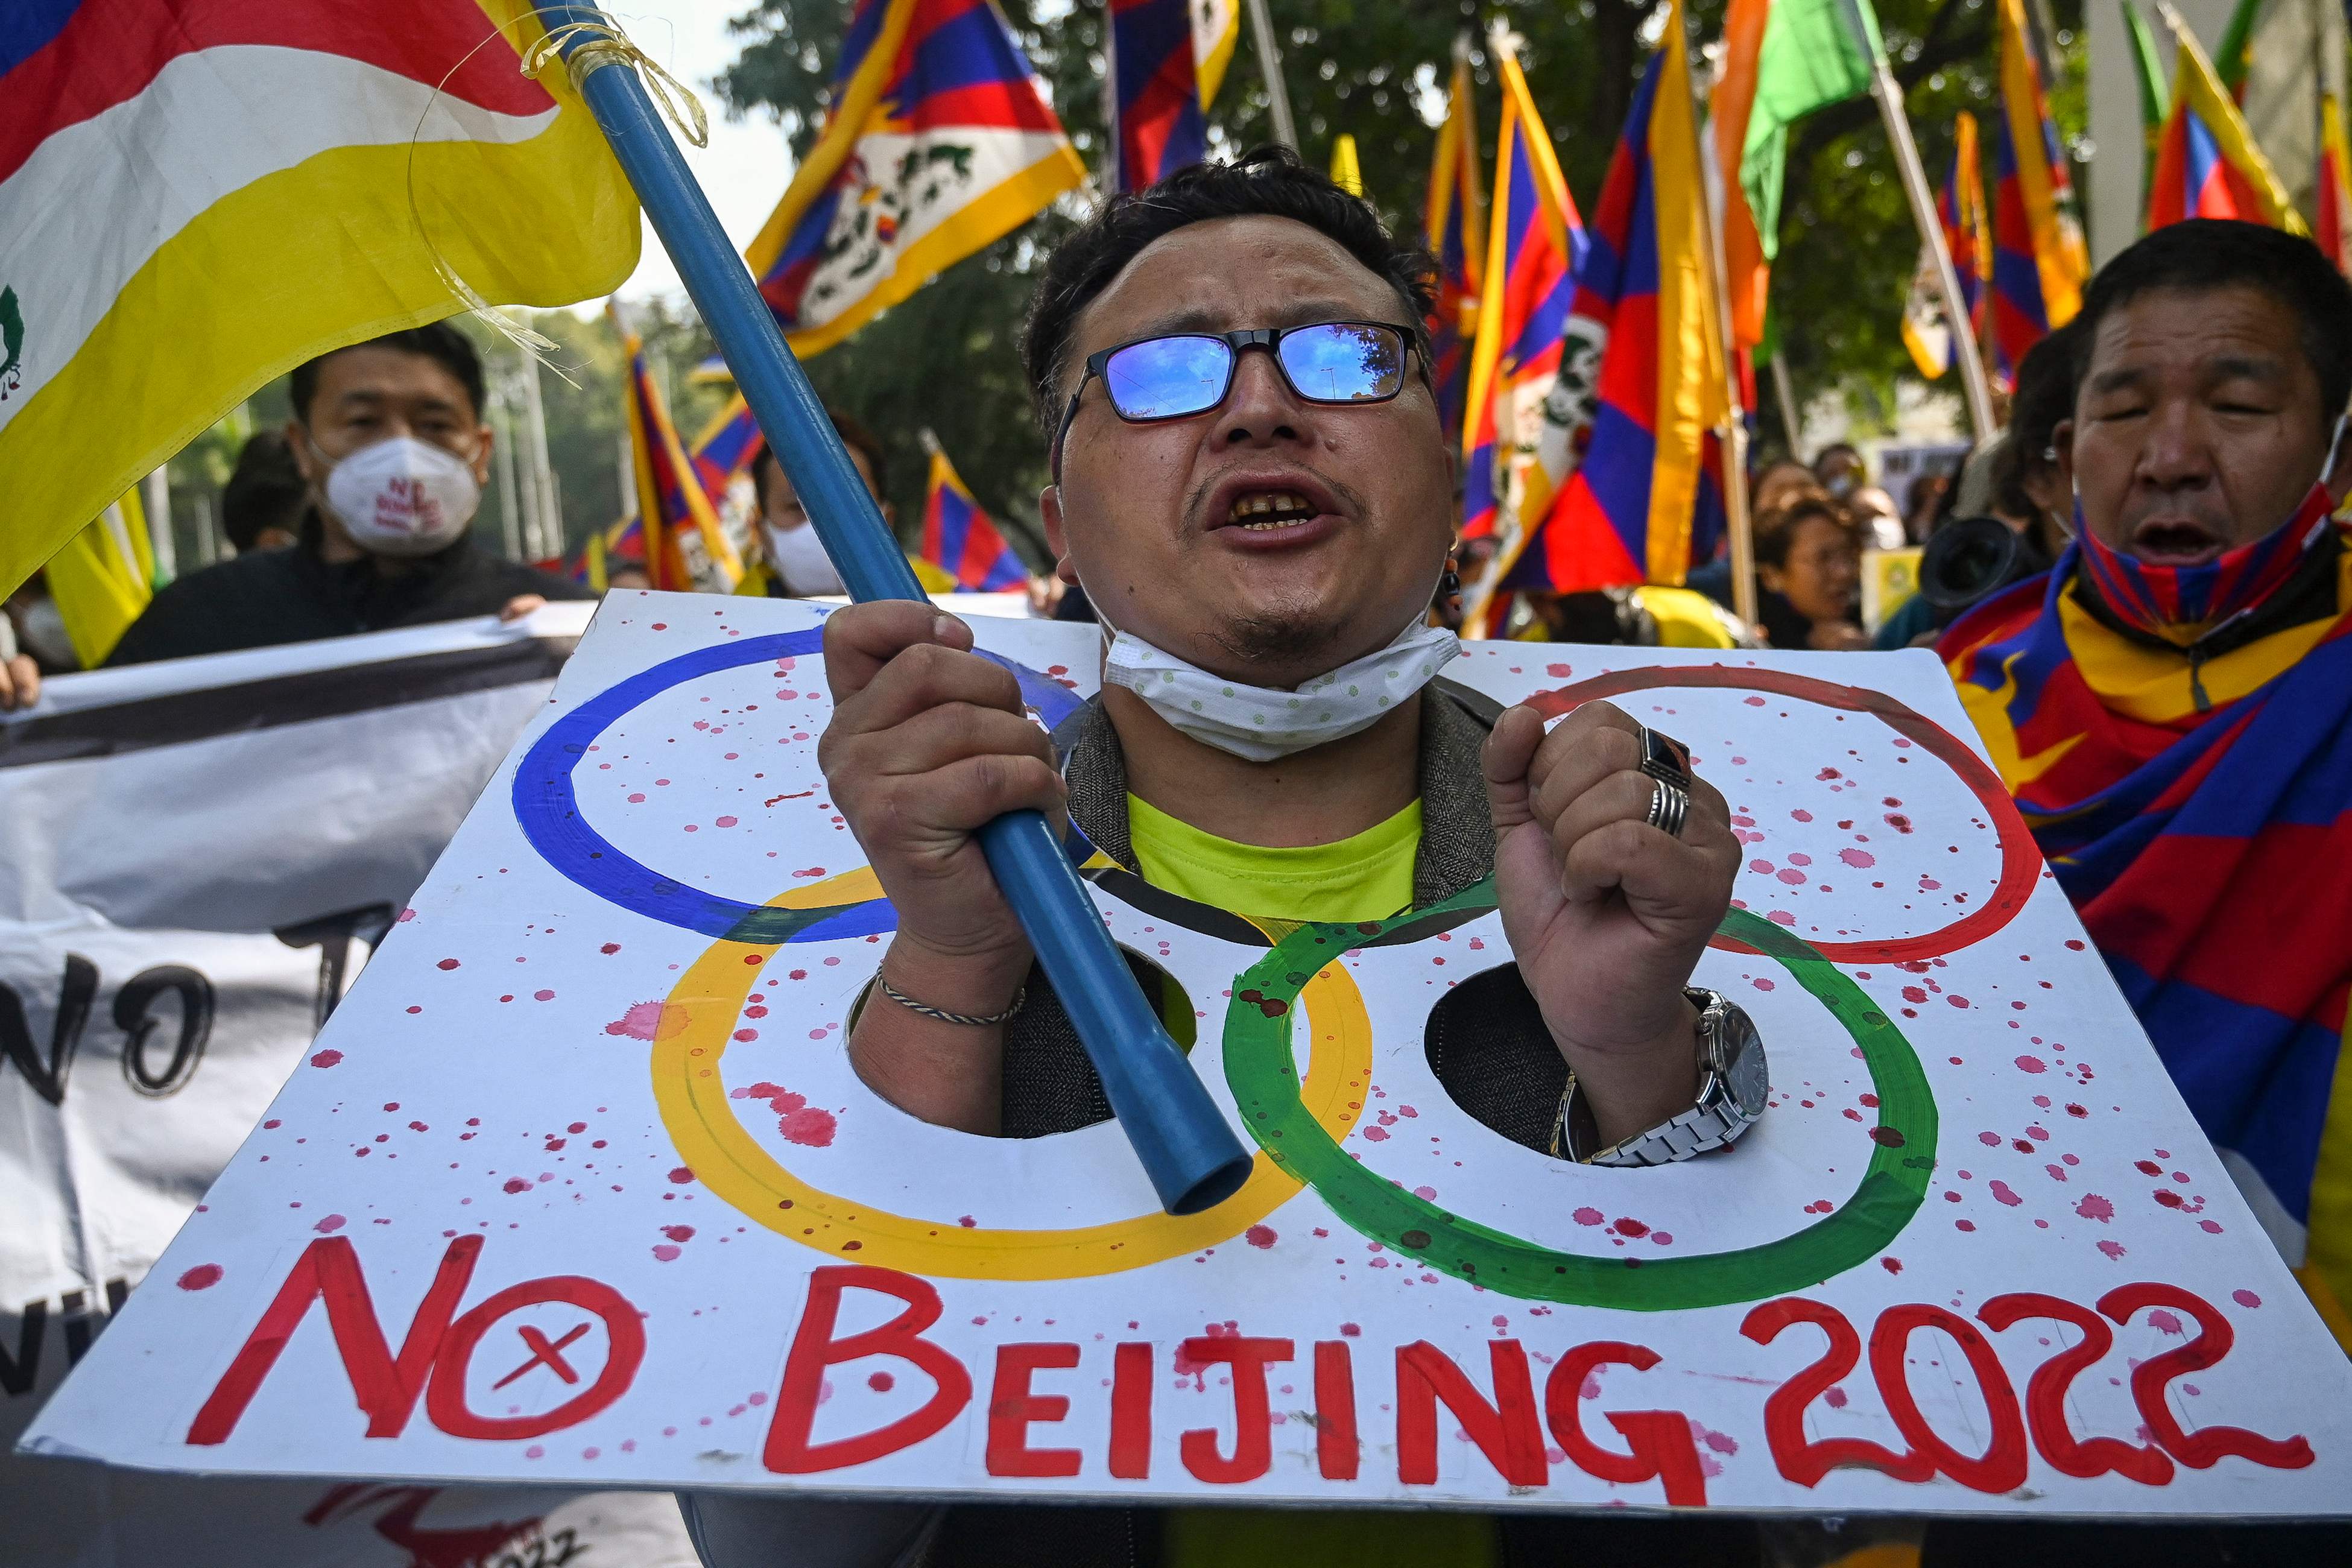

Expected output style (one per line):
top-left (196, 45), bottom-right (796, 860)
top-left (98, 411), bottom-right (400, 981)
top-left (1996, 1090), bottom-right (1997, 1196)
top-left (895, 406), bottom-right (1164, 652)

top-left (1500, 0), bottom-right (1731, 592)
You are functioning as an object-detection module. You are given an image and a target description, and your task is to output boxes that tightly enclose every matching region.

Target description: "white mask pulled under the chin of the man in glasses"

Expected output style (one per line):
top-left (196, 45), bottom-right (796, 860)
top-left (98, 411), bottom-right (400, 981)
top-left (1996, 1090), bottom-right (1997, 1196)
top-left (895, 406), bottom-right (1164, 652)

top-left (1096, 604), bottom-right (1463, 762)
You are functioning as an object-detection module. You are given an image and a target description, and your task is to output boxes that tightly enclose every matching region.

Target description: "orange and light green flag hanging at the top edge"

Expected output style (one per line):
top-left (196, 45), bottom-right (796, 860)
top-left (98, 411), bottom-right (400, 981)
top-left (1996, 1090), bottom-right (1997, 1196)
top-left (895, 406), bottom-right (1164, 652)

top-left (1710, 0), bottom-right (1882, 348)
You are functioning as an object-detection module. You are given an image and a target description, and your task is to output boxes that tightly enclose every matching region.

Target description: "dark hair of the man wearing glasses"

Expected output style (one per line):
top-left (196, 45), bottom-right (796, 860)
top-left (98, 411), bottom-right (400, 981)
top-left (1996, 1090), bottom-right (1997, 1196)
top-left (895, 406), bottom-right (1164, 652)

top-left (1021, 146), bottom-right (1437, 440)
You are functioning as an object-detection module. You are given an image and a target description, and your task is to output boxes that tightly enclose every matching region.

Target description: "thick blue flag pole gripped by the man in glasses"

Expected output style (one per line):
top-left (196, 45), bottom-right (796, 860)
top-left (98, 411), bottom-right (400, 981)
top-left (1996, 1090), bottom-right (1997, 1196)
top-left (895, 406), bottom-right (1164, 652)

top-left (539, 5), bottom-right (1249, 1213)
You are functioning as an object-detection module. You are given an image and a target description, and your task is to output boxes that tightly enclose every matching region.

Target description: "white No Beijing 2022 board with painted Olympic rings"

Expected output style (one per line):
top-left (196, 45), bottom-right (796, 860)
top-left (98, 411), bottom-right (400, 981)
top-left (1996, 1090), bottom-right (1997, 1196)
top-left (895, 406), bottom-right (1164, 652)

top-left (28, 592), bottom-right (2352, 1516)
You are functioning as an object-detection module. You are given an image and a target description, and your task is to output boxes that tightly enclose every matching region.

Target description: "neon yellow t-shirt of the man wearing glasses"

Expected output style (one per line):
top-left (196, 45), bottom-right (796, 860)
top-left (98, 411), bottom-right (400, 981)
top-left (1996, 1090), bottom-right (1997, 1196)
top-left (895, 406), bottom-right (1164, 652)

top-left (1127, 795), bottom-right (1500, 1568)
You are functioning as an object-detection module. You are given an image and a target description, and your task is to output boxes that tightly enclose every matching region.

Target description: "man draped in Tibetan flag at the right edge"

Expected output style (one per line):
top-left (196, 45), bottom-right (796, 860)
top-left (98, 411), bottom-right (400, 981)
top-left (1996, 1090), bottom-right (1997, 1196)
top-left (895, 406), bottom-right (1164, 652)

top-left (1938, 219), bottom-right (2352, 1349)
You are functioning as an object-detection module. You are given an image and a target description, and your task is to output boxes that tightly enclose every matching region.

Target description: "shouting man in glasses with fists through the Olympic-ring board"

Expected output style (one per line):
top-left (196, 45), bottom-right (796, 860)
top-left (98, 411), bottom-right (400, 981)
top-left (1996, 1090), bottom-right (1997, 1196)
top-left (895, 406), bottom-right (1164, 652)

top-left (694, 150), bottom-right (1764, 1568)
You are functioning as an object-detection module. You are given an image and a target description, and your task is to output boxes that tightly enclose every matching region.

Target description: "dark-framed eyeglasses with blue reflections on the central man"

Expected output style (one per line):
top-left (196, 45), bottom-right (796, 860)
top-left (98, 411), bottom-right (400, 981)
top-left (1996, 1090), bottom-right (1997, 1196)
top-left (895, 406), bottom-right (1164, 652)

top-left (1054, 322), bottom-right (1414, 479)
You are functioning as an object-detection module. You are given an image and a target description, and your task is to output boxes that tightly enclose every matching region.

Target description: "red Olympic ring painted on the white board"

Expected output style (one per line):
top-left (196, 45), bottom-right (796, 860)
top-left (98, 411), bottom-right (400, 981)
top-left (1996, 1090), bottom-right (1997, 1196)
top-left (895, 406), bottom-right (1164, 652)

top-left (1526, 665), bottom-right (2041, 964)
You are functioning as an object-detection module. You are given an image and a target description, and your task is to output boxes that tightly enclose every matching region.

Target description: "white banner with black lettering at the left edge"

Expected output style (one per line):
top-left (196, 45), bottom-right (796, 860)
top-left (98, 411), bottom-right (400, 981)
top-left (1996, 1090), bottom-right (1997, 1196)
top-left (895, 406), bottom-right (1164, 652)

top-left (0, 604), bottom-right (692, 1568)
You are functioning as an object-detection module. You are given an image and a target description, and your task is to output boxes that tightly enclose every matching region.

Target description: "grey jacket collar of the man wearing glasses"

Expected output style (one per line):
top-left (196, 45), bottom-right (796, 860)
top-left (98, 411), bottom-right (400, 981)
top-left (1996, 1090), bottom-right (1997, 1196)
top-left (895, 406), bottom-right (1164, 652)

top-left (1054, 681), bottom-right (1494, 905)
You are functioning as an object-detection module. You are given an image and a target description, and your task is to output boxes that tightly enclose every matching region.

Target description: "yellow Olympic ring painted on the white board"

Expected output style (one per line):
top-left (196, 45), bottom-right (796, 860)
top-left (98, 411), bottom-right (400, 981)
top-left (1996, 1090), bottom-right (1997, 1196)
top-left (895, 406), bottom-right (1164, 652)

top-left (651, 902), bottom-right (1371, 1279)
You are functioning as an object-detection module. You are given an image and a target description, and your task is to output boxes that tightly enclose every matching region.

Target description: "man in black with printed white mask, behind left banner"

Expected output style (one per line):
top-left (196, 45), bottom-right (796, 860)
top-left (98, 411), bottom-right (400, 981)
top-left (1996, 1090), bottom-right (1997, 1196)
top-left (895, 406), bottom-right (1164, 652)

top-left (108, 322), bottom-right (595, 665)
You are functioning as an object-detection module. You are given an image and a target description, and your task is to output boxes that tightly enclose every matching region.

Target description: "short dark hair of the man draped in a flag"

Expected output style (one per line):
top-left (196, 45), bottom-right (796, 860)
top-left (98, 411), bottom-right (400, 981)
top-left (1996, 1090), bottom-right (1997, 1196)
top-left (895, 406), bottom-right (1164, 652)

top-left (2072, 219), bottom-right (2352, 421)
